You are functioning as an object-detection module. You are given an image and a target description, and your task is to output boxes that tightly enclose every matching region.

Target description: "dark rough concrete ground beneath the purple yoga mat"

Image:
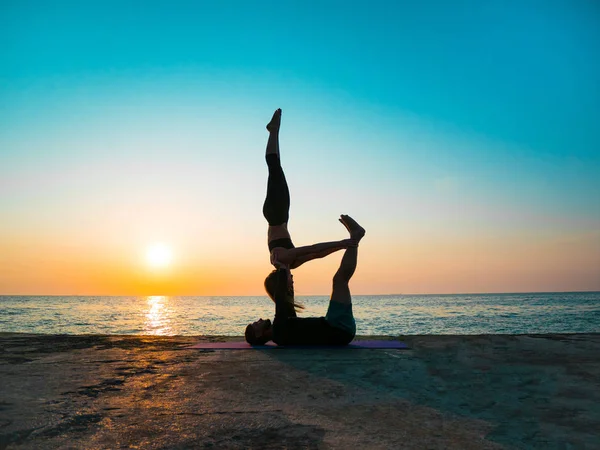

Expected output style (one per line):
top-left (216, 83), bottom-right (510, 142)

top-left (0, 334), bottom-right (600, 450)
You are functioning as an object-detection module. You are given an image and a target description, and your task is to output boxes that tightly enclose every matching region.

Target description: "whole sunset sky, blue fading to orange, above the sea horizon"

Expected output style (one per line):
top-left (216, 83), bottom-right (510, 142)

top-left (0, 0), bottom-right (600, 295)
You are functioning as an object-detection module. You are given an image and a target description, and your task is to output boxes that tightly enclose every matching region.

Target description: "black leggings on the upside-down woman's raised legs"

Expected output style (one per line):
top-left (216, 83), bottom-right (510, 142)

top-left (263, 153), bottom-right (290, 226)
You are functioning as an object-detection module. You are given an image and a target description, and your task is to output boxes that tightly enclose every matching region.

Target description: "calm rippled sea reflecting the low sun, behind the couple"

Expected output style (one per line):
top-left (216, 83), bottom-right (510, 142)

top-left (0, 292), bottom-right (600, 336)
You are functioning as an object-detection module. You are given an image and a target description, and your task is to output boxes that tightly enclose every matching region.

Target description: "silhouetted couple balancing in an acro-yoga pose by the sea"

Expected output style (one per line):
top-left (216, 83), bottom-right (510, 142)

top-left (245, 109), bottom-right (365, 345)
